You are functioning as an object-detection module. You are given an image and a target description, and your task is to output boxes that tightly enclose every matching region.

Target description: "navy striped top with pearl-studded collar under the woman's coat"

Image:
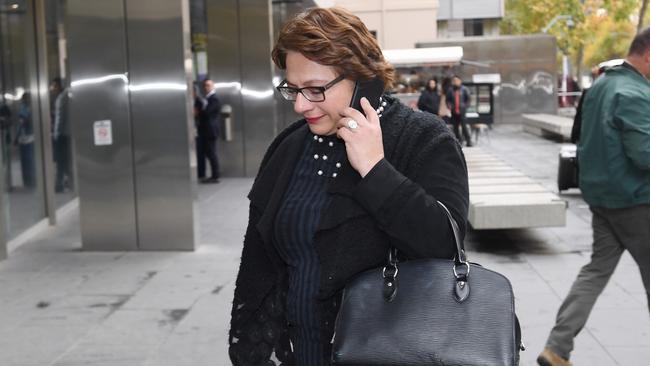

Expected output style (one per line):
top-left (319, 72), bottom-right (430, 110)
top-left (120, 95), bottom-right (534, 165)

top-left (275, 134), bottom-right (347, 366)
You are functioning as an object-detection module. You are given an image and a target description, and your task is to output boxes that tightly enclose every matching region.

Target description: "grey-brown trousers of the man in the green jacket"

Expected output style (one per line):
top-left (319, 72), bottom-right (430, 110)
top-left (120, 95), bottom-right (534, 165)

top-left (546, 205), bottom-right (650, 359)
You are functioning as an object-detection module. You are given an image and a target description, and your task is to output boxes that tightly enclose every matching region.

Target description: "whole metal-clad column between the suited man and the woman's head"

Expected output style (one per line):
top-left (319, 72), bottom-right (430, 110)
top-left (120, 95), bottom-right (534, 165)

top-left (207, 0), bottom-right (280, 176)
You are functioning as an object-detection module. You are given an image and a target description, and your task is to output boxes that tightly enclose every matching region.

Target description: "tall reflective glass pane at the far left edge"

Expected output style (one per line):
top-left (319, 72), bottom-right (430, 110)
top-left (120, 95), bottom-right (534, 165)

top-left (0, 0), bottom-right (45, 239)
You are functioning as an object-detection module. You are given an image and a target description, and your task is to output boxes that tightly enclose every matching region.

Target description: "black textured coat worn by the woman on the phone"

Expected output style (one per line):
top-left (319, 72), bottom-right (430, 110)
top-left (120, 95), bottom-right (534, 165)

top-left (230, 96), bottom-right (469, 366)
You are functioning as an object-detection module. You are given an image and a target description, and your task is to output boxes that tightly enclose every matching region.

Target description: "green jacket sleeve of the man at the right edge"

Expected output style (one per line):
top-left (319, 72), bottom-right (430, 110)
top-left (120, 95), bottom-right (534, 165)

top-left (614, 95), bottom-right (650, 170)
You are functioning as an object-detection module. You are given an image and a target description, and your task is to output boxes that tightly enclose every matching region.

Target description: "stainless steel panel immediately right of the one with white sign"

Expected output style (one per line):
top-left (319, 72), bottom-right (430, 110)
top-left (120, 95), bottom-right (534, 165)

top-left (126, 0), bottom-right (194, 250)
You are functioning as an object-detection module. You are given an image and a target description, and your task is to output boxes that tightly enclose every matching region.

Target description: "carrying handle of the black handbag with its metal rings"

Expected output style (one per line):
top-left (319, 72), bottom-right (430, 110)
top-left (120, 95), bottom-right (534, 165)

top-left (382, 201), bottom-right (470, 302)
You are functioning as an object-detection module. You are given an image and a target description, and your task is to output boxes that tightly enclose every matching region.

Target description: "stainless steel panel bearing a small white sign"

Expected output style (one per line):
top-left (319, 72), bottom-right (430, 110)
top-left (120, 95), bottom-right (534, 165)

top-left (67, 0), bottom-right (137, 250)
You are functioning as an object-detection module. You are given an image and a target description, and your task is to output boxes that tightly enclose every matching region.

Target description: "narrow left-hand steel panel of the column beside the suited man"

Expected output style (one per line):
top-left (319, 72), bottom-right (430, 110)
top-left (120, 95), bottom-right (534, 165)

top-left (206, 0), bottom-right (246, 176)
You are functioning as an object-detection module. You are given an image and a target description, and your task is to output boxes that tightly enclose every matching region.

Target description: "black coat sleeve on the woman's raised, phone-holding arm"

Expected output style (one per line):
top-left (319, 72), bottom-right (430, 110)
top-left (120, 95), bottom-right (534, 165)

top-left (356, 136), bottom-right (469, 258)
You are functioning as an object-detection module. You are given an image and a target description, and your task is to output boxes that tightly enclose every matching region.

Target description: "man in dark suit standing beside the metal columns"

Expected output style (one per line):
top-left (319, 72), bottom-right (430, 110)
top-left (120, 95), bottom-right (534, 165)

top-left (195, 79), bottom-right (221, 183)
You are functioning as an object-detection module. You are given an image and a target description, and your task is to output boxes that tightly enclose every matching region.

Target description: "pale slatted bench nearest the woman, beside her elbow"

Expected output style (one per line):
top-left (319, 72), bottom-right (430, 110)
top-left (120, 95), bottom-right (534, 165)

top-left (463, 147), bottom-right (566, 230)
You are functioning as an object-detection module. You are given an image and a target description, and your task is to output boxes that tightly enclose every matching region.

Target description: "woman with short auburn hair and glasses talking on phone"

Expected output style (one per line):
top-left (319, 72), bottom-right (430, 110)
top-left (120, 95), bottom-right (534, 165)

top-left (229, 8), bottom-right (468, 366)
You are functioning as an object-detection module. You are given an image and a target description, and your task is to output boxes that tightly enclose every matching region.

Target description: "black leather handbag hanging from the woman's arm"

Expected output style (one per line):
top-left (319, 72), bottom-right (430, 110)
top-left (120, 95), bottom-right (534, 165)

top-left (332, 202), bottom-right (523, 366)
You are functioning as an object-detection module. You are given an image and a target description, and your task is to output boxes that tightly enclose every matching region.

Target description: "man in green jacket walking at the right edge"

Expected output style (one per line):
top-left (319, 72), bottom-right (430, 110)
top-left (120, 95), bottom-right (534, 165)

top-left (537, 28), bottom-right (650, 366)
